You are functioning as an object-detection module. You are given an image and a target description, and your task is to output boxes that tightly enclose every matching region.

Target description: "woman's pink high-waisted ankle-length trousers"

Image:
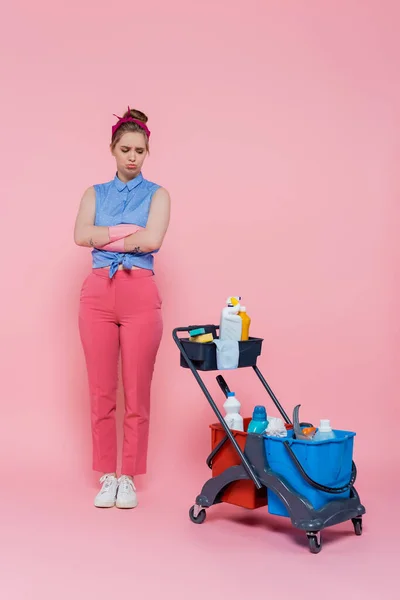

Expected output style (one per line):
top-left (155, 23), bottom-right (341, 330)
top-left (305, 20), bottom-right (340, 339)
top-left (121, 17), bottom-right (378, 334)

top-left (79, 269), bottom-right (163, 476)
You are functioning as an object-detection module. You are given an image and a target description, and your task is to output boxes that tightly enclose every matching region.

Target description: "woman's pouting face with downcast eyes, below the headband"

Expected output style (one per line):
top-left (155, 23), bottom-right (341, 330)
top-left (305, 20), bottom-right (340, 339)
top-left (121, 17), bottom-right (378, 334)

top-left (111, 131), bottom-right (147, 180)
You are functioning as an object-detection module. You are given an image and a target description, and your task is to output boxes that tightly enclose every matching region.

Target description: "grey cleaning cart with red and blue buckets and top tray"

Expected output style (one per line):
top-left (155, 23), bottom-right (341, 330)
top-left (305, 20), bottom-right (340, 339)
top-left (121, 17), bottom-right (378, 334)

top-left (172, 325), bottom-right (365, 554)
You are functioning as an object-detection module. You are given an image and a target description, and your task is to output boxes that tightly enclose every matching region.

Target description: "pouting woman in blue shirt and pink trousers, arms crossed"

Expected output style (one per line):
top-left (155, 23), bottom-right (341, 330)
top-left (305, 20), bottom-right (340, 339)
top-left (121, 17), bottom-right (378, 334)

top-left (74, 107), bottom-right (170, 508)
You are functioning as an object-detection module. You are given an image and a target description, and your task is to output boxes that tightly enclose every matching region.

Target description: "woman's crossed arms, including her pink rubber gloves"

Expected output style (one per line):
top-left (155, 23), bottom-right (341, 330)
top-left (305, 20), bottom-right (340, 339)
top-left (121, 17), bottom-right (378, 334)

top-left (74, 187), bottom-right (171, 254)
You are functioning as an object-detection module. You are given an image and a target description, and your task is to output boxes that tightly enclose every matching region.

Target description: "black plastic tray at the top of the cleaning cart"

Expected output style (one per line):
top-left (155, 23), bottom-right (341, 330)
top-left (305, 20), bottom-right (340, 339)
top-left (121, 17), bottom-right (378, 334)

top-left (180, 335), bottom-right (264, 371)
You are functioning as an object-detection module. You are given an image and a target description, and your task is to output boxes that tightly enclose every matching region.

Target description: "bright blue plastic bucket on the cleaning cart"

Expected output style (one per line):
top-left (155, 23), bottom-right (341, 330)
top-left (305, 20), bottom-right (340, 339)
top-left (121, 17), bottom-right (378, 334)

top-left (264, 429), bottom-right (356, 517)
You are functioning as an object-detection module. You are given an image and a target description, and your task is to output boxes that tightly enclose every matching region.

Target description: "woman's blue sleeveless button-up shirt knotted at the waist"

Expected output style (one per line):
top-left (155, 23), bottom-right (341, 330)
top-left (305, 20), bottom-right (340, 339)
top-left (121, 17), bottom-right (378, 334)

top-left (92, 173), bottom-right (161, 278)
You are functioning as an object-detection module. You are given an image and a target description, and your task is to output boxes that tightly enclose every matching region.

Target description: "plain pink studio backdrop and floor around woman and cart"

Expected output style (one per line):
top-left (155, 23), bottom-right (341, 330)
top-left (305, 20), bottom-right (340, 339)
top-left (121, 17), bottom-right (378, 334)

top-left (0, 0), bottom-right (400, 600)
